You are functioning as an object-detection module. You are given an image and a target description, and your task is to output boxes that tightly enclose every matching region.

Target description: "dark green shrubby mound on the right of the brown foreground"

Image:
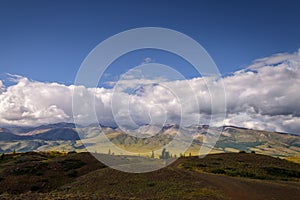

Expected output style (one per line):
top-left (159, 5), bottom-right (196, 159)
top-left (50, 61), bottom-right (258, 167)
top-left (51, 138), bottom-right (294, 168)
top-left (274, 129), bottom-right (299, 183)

top-left (182, 152), bottom-right (300, 181)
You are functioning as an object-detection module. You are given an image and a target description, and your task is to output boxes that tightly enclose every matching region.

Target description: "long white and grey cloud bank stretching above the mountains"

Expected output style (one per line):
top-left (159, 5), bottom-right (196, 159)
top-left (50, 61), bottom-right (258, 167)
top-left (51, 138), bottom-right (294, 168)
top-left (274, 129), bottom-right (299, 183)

top-left (0, 51), bottom-right (300, 133)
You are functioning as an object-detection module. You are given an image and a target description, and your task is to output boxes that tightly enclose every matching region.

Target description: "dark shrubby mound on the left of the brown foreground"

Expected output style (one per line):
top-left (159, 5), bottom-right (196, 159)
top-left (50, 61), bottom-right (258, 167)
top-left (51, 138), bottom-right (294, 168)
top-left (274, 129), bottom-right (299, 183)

top-left (0, 151), bottom-right (104, 195)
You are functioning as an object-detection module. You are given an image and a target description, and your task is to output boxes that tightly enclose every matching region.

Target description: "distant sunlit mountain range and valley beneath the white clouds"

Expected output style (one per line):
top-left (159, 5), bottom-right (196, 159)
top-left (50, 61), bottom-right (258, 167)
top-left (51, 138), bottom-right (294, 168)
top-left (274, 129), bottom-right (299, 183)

top-left (0, 123), bottom-right (300, 157)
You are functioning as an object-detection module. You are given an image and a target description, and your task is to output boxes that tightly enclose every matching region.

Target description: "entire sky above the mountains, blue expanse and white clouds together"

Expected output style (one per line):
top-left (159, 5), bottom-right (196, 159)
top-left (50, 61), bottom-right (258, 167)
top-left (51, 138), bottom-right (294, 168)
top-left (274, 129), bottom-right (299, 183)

top-left (0, 0), bottom-right (300, 134)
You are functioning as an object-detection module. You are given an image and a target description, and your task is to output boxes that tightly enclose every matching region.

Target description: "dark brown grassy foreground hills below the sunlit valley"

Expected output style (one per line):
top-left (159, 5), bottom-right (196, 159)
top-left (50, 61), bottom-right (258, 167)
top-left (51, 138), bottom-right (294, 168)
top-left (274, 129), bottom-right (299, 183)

top-left (0, 153), bottom-right (300, 199)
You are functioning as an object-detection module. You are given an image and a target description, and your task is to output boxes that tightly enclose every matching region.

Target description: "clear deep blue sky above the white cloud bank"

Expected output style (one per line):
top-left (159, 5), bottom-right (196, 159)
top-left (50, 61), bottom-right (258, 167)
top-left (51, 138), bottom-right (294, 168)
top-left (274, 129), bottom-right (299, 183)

top-left (0, 0), bottom-right (300, 85)
